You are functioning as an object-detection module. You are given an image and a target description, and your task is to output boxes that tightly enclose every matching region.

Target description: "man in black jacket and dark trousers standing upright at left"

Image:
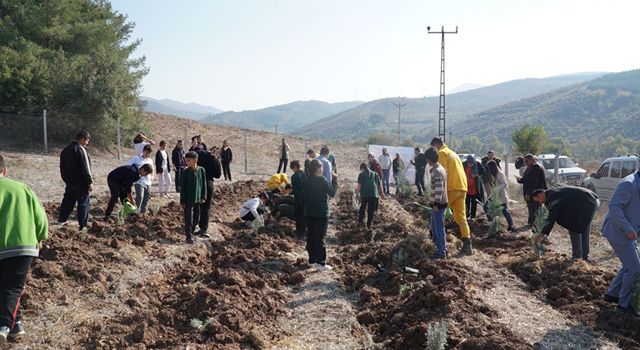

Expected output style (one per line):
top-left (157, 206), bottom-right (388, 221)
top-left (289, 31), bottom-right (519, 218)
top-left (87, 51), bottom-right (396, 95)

top-left (58, 131), bottom-right (93, 230)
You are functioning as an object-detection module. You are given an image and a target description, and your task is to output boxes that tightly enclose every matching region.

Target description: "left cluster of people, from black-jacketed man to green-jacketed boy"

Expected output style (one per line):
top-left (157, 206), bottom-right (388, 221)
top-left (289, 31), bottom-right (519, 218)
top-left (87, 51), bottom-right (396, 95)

top-left (53, 131), bottom-right (233, 243)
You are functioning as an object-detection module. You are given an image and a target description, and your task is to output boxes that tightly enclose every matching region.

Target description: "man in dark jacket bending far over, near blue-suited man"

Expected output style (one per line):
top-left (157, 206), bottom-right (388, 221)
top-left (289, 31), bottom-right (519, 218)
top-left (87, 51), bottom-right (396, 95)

top-left (532, 186), bottom-right (600, 261)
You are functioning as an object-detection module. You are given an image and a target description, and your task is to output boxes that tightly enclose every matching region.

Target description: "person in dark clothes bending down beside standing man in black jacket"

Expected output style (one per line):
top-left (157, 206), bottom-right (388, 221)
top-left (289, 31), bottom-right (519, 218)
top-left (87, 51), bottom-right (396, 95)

top-left (104, 164), bottom-right (153, 220)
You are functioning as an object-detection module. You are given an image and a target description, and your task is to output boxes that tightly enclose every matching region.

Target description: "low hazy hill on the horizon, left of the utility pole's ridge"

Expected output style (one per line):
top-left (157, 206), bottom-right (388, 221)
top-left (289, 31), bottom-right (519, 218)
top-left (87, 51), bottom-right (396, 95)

top-left (202, 100), bottom-right (362, 133)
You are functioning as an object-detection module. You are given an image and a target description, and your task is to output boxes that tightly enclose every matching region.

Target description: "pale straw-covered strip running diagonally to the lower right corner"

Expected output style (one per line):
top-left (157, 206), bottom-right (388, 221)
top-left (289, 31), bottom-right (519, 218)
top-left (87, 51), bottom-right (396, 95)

top-left (458, 250), bottom-right (619, 349)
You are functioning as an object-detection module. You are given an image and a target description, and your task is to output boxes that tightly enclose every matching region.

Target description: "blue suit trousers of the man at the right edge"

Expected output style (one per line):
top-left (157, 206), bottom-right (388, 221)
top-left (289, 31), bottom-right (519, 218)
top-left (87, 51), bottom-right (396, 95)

top-left (607, 239), bottom-right (640, 307)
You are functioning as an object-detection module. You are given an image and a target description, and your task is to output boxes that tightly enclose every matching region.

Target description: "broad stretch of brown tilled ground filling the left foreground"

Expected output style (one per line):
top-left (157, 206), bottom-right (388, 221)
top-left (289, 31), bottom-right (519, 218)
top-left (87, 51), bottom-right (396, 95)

top-left (18, 182), bottom-right (306, 349)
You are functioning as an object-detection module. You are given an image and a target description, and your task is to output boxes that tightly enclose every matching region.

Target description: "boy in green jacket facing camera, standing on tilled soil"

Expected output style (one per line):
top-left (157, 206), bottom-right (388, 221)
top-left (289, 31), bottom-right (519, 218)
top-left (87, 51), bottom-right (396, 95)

top-left (180, 151), bottom-right (207, 244)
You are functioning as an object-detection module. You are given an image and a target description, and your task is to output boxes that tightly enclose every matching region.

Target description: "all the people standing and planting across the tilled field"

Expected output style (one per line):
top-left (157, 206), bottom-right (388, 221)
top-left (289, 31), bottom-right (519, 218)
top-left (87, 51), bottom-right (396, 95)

top-left (0, 131), bottom-right (640, 343)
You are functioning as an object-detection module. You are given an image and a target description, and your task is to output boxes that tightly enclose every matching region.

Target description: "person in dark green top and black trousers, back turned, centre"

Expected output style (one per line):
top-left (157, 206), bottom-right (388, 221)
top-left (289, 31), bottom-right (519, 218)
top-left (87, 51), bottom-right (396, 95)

top-left (302, 159), bottom-right (338, 271)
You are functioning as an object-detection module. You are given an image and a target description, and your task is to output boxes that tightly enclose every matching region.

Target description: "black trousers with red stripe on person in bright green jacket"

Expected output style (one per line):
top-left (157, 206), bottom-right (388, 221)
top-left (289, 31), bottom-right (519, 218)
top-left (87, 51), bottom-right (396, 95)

top-left (0, 256), bottom-right (33, 329)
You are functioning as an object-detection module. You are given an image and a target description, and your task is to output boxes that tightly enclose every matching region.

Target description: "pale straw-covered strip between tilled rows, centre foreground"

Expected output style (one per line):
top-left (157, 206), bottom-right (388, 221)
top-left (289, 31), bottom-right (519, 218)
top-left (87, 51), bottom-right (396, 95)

top-left (271, 223), bottom-right (374, 350)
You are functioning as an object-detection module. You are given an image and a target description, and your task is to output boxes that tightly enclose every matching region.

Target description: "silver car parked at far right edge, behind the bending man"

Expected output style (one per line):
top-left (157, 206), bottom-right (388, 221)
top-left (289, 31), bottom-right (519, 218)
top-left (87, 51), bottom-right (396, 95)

top-left (582, 155), bottom-right (639, 200)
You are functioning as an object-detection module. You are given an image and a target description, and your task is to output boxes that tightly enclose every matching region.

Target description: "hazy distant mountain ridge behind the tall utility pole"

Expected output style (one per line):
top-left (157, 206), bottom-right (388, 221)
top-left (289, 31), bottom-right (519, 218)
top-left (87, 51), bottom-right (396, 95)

top-left (293, 73), bottom-right (606, 140)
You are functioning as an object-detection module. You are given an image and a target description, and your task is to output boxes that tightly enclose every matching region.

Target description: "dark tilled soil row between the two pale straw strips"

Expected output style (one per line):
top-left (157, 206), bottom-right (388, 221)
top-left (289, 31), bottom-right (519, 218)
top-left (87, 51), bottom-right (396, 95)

top-left (336, 192), bottom-right (532, 349)
